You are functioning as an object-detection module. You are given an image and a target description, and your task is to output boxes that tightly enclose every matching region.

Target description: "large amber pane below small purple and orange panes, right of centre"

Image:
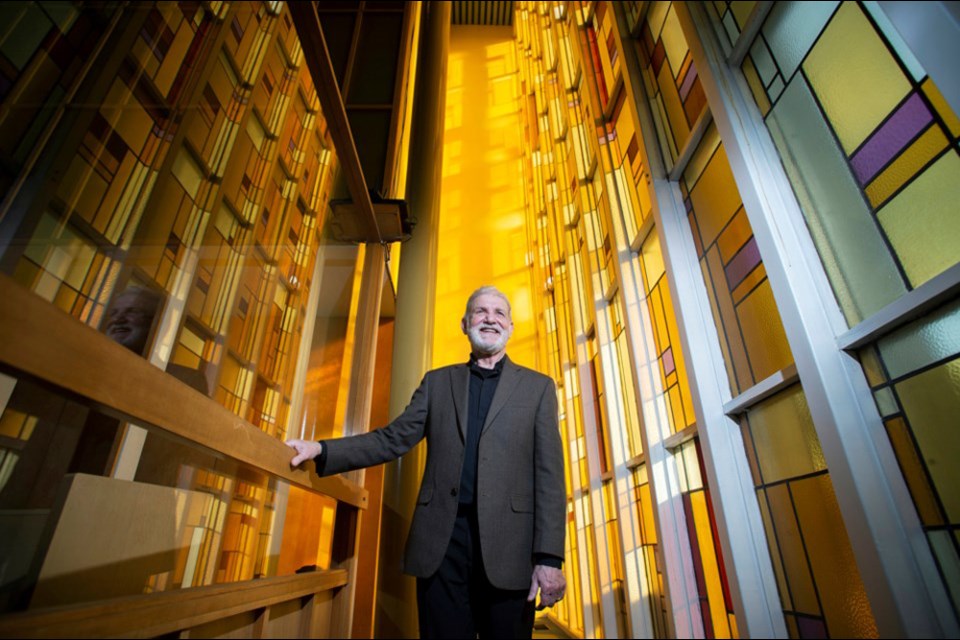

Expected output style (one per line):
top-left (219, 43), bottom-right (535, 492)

top-left (737, 280), bottom-right (793, 382)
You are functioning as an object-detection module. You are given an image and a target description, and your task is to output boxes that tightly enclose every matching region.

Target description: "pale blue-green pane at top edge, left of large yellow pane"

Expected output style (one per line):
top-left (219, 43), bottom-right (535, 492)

top-left (763, 2), bottom-right (840, 78)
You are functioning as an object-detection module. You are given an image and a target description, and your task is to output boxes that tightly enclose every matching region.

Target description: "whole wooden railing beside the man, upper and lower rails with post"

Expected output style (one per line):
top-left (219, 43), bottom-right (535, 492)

top-left (0, 275), bottom-right (368, 638)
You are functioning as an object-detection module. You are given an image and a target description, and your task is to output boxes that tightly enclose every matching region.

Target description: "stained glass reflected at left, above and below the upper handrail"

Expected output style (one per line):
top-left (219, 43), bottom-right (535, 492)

top-left (0, 2), bottom-right (344, 604)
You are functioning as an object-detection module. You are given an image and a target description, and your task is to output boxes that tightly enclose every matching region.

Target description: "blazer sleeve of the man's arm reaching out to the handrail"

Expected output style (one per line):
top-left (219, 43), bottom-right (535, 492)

top-left (317, 376), bottom-right (430, 476)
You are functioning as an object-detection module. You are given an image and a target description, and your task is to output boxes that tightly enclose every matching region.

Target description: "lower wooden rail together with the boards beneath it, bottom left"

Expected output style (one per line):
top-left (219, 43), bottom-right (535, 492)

top-left (0, 570), bottom-right (347, 638)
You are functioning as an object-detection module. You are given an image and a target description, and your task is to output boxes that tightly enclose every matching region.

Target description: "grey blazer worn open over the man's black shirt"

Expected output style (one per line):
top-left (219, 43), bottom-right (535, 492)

top-left (322, 359), bottom-right (567, 589)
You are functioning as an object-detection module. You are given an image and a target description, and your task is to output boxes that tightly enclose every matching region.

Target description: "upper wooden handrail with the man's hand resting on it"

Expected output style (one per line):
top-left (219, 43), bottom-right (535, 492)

top-left (0, 276), bottom-right (368, 509)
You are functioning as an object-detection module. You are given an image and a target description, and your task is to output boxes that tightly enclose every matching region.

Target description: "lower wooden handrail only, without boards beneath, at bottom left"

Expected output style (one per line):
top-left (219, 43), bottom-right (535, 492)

top-left (0, 570), bottom-right (347, 638)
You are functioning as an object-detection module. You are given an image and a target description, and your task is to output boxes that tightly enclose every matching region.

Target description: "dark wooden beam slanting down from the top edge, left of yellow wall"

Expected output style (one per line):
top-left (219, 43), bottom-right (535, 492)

top-left (287, 2), bottom-right (383, 243)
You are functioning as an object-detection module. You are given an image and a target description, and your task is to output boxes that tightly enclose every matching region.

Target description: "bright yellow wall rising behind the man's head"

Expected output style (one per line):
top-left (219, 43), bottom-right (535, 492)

top-left (433, 25), bottom-right (538, 368)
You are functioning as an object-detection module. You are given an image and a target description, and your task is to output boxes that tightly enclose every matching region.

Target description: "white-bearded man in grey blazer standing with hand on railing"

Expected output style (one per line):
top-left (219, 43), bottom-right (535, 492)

top-left (287, 287), bottom-right (566, 638)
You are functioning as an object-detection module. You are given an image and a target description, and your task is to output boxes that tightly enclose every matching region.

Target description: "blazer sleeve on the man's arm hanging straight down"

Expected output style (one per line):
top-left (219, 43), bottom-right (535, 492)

top-left (533, 380), bottom-right (567, 558)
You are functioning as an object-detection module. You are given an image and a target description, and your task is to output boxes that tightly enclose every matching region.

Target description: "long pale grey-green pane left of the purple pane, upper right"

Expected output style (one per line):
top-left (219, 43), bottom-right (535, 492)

top-left (767, 77), bottom-right (906, 325)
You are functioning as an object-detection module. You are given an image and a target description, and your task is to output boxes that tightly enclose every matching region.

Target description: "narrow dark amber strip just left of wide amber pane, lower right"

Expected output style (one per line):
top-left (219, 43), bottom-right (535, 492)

top-left (767, 484), bottom-right (820, 616)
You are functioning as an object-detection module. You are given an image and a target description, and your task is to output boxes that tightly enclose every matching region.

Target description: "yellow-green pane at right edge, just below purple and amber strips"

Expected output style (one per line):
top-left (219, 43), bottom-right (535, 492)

top-left (877, 151), bottom-right (960, 287)
